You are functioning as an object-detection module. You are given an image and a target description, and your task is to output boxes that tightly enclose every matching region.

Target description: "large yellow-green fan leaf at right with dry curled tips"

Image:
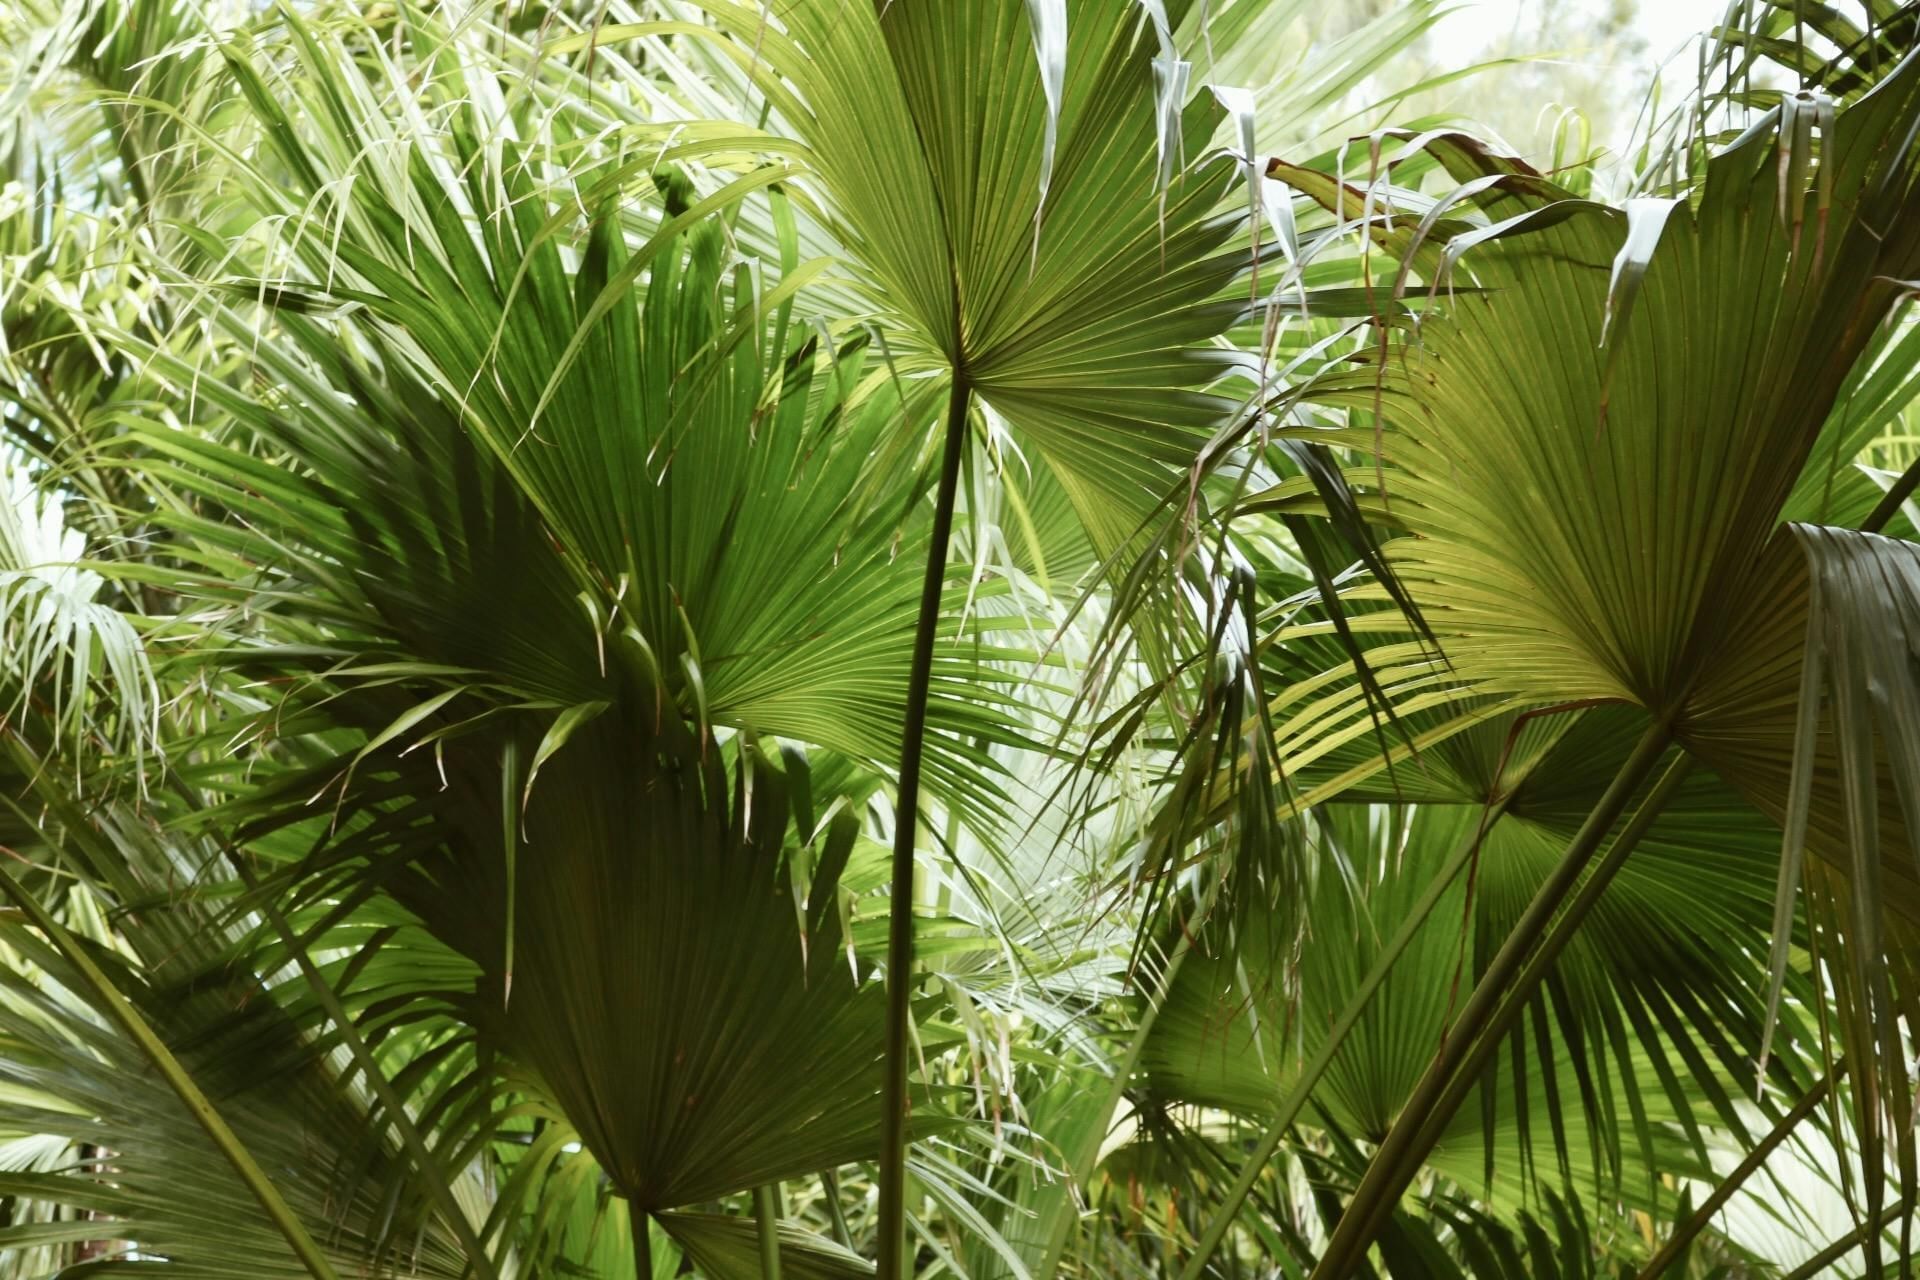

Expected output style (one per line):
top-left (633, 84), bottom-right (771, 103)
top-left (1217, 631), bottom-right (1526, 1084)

top-left (1327, 61), bottom-right (1920, 735)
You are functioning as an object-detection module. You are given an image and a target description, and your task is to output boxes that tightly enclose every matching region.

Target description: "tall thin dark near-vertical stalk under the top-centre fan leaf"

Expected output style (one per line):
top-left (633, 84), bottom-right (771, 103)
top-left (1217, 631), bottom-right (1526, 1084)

top-left (874, 368), bottom-right (972, 1280)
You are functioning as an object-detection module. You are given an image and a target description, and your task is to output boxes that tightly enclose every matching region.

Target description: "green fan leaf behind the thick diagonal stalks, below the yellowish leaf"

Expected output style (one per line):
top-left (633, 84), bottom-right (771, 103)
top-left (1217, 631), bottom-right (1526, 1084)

top-left (1142, 708), bottom-right (1807, 1215)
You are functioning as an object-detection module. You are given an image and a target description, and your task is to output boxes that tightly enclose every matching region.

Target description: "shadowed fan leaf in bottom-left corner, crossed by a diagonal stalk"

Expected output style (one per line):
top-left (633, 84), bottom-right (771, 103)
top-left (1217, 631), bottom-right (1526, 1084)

top-left (0, 736), bottom-right (482, 1280)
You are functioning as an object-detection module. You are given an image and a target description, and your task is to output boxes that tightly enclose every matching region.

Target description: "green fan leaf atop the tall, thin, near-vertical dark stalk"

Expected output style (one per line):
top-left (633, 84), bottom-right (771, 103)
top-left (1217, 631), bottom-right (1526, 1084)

top-left (683, 0), bottom-right (1250, 555)
